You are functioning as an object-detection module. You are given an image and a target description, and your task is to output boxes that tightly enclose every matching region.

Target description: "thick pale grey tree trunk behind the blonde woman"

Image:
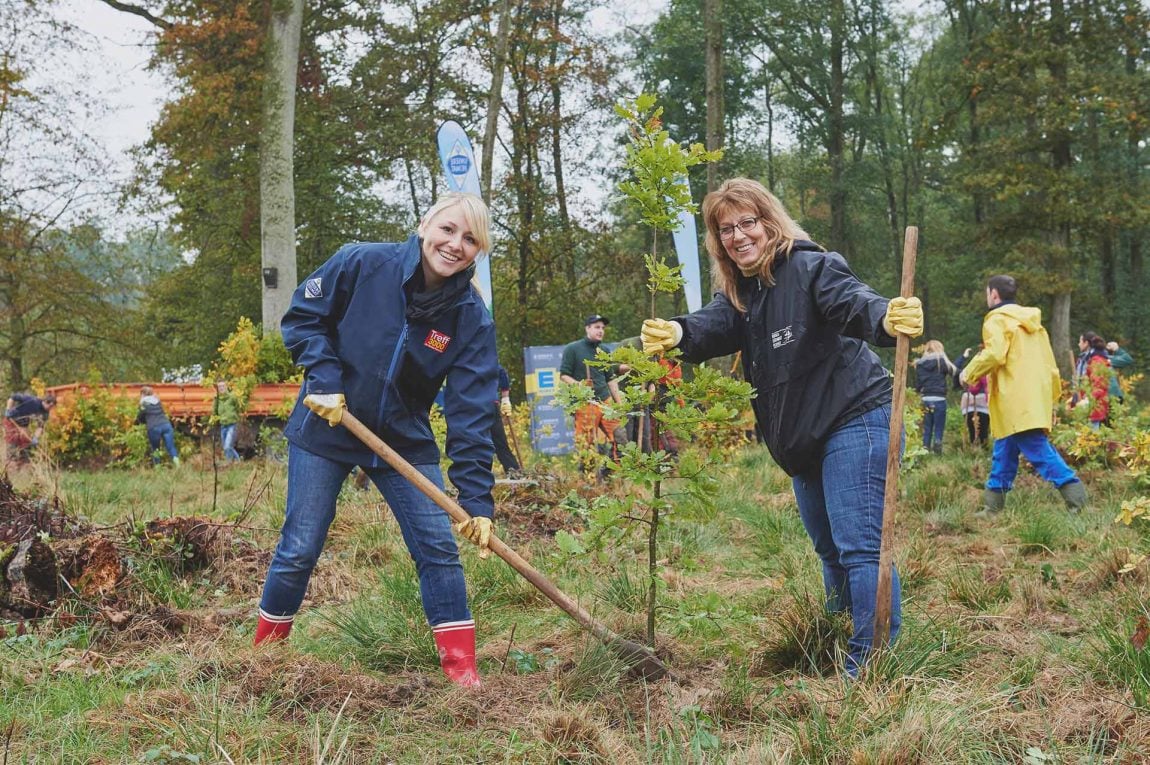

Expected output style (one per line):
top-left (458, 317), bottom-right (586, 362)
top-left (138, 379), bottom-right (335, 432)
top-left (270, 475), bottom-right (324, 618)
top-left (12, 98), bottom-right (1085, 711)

top-left (260, 0), bottom-right (304, 332)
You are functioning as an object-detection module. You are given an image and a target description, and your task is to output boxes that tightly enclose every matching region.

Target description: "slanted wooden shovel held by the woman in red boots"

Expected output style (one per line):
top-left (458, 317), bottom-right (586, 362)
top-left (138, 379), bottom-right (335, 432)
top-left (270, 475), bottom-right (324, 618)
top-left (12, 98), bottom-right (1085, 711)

top-left (339, 410), bottom-right (667, 680)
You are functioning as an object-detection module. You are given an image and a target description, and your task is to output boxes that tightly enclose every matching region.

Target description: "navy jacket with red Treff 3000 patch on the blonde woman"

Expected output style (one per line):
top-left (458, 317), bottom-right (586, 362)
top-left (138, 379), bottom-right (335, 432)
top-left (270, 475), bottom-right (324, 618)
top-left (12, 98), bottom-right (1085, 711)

top-left (281, 236), bottom-right (499, 518)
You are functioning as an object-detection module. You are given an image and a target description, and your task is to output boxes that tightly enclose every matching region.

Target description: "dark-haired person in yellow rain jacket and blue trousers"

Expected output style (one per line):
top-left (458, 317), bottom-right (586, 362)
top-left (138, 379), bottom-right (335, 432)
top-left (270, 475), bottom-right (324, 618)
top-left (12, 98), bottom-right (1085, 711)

top-left (959, 275), bottom-right (1086, 514)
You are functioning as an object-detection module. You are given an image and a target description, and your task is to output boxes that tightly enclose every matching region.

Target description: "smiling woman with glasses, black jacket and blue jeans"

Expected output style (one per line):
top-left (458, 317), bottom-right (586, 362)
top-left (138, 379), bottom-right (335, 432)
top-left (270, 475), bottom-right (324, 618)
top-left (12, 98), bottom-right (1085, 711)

top-left (642, 178), bottom-right (922, 675)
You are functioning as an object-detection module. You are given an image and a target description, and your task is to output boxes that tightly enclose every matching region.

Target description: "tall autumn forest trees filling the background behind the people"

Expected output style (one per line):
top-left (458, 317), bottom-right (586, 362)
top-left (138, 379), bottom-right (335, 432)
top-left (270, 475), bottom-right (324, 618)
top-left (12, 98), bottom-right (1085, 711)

top-left (0, 0), bottom-right (1150, 392)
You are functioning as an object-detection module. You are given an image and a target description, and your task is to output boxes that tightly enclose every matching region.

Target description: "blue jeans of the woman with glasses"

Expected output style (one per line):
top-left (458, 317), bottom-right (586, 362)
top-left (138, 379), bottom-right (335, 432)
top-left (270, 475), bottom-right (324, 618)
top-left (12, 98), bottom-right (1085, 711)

top-left (792, 406), bottom-right (903, 675)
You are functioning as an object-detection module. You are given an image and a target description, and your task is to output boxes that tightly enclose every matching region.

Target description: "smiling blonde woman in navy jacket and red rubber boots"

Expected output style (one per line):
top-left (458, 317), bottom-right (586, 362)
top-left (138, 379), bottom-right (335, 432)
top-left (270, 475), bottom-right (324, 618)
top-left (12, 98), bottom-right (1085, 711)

top-left (255, 193), bottom-right (499, 686)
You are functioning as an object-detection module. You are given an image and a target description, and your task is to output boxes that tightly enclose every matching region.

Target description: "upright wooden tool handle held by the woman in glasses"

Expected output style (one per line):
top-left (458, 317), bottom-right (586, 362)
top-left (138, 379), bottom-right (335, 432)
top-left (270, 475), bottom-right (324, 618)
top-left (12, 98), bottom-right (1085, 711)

top-left (873, 225), bottom-right (919, 649)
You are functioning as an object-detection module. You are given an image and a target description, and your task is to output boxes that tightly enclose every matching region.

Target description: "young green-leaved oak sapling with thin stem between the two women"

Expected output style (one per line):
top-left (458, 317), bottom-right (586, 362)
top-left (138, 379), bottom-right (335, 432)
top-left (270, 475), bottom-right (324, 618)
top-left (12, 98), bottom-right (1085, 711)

top-left (557, 94), bottom-right (752, 647)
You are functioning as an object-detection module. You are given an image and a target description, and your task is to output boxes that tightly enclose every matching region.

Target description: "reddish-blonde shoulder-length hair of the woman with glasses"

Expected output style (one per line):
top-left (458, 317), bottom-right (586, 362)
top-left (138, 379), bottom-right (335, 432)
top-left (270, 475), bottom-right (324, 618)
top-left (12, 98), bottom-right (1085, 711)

top-left (703, 178), bottom-right (811, 311)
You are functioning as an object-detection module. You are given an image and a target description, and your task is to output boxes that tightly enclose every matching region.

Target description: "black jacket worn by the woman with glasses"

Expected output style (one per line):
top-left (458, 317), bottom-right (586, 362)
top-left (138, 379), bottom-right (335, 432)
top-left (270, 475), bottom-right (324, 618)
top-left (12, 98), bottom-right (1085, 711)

top-left (675, 240), bottom-right (895, 475)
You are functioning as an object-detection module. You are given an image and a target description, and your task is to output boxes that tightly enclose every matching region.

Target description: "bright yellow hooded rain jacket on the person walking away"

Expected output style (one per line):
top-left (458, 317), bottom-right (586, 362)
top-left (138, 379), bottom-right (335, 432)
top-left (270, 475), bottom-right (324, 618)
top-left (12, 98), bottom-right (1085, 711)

top-left (963, 303), bottom-right (1061, 438)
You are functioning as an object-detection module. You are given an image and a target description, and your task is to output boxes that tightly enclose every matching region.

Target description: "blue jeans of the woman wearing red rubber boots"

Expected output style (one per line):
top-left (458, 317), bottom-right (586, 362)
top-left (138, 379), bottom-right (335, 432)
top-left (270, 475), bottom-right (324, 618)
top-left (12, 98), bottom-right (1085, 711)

top-left (260, 444), bottom-right (472, 626)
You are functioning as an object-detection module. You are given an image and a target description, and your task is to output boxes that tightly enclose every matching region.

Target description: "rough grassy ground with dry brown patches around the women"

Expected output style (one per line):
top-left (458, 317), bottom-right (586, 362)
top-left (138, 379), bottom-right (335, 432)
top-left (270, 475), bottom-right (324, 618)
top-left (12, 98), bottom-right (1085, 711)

top-left (0, 439), bottom-right (1150, 765)
